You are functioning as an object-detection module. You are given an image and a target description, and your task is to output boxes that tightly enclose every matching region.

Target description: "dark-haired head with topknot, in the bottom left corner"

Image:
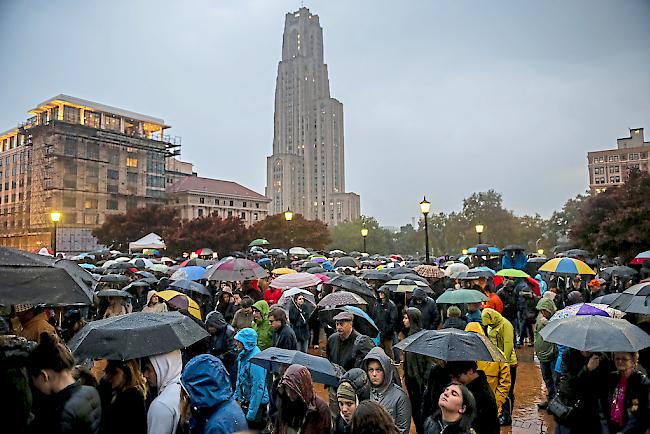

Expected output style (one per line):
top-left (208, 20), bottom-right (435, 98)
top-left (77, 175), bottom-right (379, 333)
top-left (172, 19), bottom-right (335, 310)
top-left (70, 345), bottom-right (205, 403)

top-left (27, 332), bottom-right (74, 395)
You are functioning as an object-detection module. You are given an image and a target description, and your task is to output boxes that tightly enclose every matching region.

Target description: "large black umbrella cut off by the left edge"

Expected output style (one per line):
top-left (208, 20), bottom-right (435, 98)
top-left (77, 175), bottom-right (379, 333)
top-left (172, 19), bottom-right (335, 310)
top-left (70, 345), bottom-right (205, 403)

top-left (0, 247), bottom-right (95, 305)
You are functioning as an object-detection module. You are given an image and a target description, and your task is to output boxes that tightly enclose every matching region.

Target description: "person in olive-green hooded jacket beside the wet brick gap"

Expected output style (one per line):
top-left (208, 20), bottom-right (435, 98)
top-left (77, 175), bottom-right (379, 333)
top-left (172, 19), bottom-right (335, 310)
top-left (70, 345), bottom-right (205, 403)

top-left (535, 297), bottom-right (557, 410)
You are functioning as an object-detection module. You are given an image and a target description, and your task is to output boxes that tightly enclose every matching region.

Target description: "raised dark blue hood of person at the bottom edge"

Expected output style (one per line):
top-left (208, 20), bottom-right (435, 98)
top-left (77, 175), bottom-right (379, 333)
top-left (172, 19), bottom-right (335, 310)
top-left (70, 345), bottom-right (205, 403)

top-left (181, 354), bottom-right (233, 411)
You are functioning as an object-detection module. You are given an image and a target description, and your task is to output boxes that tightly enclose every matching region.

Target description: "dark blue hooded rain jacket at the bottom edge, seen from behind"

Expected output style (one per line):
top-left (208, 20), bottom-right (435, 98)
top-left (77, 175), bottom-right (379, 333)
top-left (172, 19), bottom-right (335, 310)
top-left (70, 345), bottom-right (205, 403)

top-left (181, 354), bottom-right (248, 434)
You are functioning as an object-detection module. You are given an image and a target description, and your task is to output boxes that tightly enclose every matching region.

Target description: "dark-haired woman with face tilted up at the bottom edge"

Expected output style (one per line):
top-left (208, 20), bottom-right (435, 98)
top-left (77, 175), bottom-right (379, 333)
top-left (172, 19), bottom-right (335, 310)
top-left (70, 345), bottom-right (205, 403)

top-left (424, 383), bottom-right (476, 434)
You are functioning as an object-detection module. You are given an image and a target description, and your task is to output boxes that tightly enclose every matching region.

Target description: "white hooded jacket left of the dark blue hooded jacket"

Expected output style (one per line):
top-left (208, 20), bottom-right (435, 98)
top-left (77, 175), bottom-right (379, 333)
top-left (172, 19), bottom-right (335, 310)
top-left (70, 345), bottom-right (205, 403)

top-left (147, 350), bottom-right (183, 434)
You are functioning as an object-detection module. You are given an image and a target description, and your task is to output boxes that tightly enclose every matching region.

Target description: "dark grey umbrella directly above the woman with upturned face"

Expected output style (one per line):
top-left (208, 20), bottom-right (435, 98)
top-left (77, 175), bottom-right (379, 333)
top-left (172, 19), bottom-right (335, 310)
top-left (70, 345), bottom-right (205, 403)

top-left (395, 328), bottom-right (506, 362)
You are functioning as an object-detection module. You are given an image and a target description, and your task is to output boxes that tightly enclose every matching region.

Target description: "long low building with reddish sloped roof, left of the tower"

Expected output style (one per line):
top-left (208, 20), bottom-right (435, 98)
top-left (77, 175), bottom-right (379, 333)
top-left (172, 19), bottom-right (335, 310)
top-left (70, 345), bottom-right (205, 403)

top-left (167, 176), bottom-right (271, 226)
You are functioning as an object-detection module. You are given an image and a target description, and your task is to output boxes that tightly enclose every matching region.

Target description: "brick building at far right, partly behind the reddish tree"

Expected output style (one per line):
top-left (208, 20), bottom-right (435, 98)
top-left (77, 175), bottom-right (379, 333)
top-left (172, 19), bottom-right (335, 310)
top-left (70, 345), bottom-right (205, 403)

top-left (587, 128), bottom-right (650, 193)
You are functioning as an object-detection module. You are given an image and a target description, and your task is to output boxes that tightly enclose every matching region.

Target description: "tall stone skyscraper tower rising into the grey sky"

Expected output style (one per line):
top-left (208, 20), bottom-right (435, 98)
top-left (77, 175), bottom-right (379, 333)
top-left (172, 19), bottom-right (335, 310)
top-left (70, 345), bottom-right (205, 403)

top-left (266, 7), bottom-right (360, 225)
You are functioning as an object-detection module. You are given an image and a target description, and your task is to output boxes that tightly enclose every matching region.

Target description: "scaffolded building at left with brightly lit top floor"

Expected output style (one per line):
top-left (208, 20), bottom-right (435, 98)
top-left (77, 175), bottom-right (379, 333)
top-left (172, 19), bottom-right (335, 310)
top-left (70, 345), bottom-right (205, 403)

top-left (0, 95), bottom-right (180, 252)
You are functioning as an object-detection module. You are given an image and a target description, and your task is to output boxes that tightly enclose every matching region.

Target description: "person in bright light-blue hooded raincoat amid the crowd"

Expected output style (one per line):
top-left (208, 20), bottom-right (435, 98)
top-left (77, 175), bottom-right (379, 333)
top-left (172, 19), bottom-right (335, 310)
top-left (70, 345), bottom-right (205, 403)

top-left (235, 328), bottom-right (269, 421)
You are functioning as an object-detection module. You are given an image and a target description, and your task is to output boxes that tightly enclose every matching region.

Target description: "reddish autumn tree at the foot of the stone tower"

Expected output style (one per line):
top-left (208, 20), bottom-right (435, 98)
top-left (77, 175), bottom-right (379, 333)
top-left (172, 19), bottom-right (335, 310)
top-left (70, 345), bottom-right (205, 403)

top-left (250, 214), bottom-right (330, 250)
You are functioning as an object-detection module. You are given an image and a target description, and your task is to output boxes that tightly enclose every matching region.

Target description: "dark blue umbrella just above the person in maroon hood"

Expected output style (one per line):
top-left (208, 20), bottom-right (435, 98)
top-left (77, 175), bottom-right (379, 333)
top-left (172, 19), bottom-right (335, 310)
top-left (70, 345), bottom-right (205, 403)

top-left (251, 347), bottom-right (339, 387)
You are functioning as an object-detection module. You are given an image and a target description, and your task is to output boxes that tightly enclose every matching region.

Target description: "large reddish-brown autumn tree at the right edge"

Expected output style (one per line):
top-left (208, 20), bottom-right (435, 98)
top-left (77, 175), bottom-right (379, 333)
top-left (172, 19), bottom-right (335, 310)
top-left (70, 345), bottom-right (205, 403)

top-left (570, 170), bottom-right (650, 260)
